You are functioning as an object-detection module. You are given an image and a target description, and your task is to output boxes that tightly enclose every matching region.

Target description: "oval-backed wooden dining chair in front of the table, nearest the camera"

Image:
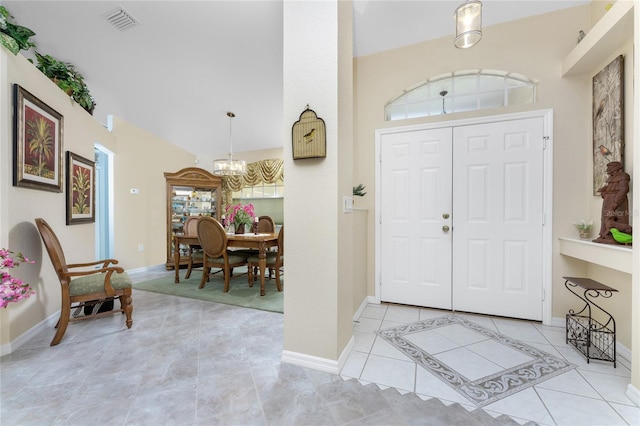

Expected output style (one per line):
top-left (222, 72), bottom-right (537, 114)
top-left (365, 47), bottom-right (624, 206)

top-left (198, 216), bottom-right (248, 293)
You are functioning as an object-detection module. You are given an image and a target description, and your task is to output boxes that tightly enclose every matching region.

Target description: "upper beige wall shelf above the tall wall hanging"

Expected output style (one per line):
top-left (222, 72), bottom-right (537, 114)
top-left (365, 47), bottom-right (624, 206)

top-left (562, 0), bottom-right (634, 77)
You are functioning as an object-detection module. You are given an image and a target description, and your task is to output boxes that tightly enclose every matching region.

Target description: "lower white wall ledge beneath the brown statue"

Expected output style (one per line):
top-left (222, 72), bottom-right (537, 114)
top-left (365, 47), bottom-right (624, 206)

top-left (558, 237), bottom-right (633, 274)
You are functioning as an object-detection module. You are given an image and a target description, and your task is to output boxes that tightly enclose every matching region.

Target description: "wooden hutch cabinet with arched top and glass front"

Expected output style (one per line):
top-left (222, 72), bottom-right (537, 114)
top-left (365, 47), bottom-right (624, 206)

top-left (164, 167), bottom-right (222, 269)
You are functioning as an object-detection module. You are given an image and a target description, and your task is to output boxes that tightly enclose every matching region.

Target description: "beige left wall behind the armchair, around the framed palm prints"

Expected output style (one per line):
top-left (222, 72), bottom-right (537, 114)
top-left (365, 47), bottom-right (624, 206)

top-left (0, 48), bottom-right (115, 352)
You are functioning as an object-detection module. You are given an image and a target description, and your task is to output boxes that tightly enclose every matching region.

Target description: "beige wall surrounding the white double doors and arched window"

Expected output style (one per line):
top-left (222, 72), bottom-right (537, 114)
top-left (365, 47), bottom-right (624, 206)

top-left (354, 5), bottom-right (633, 348)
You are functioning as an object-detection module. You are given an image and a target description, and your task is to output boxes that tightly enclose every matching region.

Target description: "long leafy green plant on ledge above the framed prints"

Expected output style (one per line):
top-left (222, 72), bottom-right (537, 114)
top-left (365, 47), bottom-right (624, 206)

top-left (34, 52), bottom-right (96, 114)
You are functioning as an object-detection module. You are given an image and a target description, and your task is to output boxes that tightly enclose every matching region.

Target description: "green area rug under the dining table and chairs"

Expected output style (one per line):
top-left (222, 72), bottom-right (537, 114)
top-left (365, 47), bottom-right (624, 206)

top-left (133, 271), bottom-right (284, 313)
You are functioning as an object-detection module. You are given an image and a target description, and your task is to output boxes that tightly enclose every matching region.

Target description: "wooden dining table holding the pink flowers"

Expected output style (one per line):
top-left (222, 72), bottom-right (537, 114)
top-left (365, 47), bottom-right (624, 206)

top-left (173, 232), bottom-right (278, 296)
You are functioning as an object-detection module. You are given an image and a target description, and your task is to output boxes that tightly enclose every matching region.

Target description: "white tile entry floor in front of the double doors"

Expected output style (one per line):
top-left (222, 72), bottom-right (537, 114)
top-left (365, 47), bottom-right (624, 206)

top-left (340, 304), bottom-right (640, 426)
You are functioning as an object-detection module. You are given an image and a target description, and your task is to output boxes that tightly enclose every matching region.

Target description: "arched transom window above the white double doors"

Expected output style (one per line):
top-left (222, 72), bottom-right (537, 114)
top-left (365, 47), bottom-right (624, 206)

top-left (385, 70), bottom-right (536, 121)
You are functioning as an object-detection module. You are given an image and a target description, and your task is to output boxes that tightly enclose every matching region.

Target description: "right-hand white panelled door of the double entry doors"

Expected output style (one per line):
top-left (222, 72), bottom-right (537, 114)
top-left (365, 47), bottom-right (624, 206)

top-left (452, 117), bottom-right (544, 321)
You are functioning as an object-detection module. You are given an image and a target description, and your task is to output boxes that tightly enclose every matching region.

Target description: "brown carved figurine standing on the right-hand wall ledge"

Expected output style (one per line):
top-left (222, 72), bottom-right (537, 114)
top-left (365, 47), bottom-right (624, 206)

top-left (593, 161), bottom-right (631, 244)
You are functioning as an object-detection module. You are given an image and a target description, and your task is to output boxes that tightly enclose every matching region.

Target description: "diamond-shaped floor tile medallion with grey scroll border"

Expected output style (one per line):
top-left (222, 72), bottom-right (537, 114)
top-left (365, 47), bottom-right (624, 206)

top-left (376, 315), bottom-right (576, 407)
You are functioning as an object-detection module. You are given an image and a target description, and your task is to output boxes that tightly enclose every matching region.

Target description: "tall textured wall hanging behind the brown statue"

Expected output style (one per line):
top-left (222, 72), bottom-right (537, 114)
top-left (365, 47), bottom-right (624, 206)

top-left (592, 55), bottom-right (624, 195)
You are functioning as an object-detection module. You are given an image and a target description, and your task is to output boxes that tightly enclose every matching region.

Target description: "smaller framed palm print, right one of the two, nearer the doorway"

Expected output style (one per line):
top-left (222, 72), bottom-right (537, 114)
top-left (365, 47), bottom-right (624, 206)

top-left (67, 151), bottom-right (96, 225)
